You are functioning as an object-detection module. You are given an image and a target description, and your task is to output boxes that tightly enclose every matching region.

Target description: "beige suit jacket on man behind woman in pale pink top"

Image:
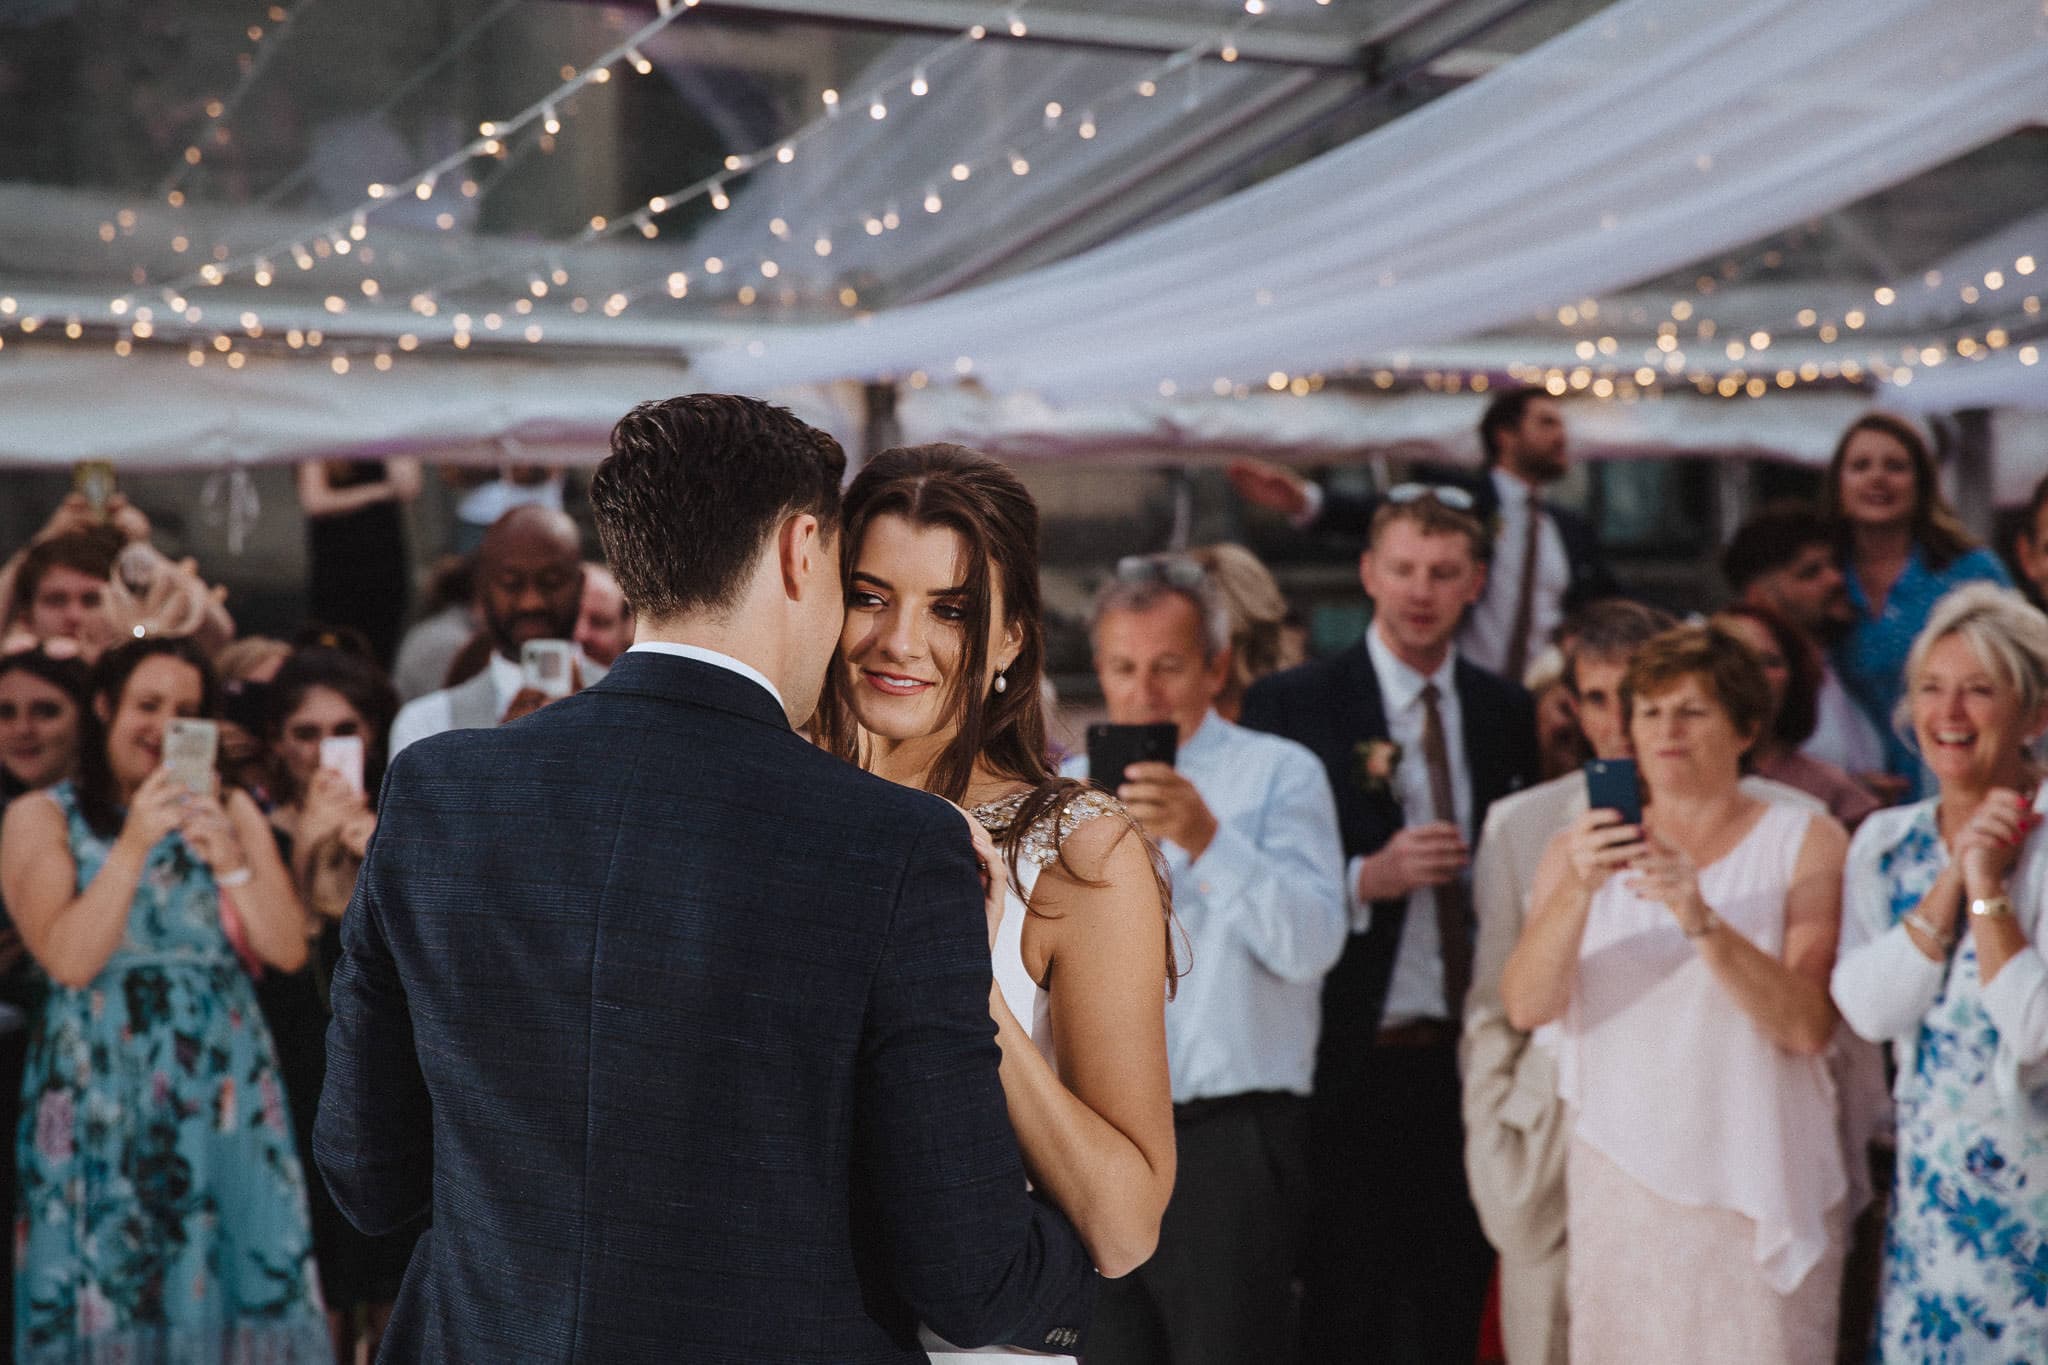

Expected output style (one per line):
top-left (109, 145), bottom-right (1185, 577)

top-left (1458, 774), bottom-right (1827, 1261)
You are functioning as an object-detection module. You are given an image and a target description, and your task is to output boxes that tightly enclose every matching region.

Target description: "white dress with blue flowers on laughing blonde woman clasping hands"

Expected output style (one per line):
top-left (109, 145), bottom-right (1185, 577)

top-left (1874, 802), bottom-right (2048, 1365)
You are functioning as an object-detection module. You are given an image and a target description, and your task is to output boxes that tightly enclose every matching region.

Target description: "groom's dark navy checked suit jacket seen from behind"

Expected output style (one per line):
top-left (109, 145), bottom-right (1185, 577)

top-left (313, 653), bottom-right (1094, 1365)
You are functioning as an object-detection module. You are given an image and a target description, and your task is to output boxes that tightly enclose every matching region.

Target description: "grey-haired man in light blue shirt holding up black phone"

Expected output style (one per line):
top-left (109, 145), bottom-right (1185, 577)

top-left (1065, 557), bottom-right (1346, 1365)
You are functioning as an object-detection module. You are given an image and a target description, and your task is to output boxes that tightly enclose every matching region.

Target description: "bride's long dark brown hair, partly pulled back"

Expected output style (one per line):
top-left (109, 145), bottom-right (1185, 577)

top-left (817, 442), bottom-right (1176, 982)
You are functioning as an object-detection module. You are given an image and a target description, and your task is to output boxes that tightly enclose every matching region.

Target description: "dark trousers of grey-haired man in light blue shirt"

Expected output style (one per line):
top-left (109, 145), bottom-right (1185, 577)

top-left (1087, 1093), bottom-right (1309, 1365)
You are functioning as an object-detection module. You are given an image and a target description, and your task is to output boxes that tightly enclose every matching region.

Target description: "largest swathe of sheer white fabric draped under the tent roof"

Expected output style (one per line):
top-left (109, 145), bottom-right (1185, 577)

top-left (696, 0), bottom-right (2048, 399)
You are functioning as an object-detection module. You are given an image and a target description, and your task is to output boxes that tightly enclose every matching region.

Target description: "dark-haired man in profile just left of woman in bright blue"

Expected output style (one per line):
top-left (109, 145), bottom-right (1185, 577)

top-left (1720, 503), bottom-right (1875, 800)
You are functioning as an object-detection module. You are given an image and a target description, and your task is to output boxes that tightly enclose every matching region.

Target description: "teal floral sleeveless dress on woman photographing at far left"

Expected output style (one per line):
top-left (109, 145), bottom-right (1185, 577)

top-left (14, 784), bottom-right (334, 1365)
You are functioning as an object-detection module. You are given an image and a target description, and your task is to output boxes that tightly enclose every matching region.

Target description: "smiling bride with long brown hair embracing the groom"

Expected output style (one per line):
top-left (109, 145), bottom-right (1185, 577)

top-left (817, 444), bottom-right (1174, 1359)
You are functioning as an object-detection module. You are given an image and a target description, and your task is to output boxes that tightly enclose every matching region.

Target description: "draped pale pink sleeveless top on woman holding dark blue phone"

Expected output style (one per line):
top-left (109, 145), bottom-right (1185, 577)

top-left (1559, 804), bottom-right (1847, 1293)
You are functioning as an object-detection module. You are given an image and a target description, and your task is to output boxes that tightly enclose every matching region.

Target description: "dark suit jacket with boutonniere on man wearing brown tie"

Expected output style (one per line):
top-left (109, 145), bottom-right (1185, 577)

top-left (1241, 641), bottom-right (1542, 1097)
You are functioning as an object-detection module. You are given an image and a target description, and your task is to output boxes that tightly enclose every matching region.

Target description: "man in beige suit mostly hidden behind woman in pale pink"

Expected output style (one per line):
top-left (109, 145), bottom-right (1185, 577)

top-left (1458, 598), bottom-right (1825, 1365)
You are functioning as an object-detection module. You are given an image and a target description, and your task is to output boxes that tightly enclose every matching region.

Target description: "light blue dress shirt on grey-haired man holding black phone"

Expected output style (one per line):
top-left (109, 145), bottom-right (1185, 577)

top-left (1061, 712), bottom-right (1348, 1103)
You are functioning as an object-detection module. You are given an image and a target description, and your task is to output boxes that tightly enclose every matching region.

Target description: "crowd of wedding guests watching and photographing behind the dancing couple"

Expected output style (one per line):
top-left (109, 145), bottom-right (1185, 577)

top-left (0, 391), bottom-right (2048, 1365)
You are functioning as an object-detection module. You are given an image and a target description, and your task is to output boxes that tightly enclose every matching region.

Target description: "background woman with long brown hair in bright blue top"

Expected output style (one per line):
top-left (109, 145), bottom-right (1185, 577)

top-left (1823, 413), bottom-right (2011, 798)
